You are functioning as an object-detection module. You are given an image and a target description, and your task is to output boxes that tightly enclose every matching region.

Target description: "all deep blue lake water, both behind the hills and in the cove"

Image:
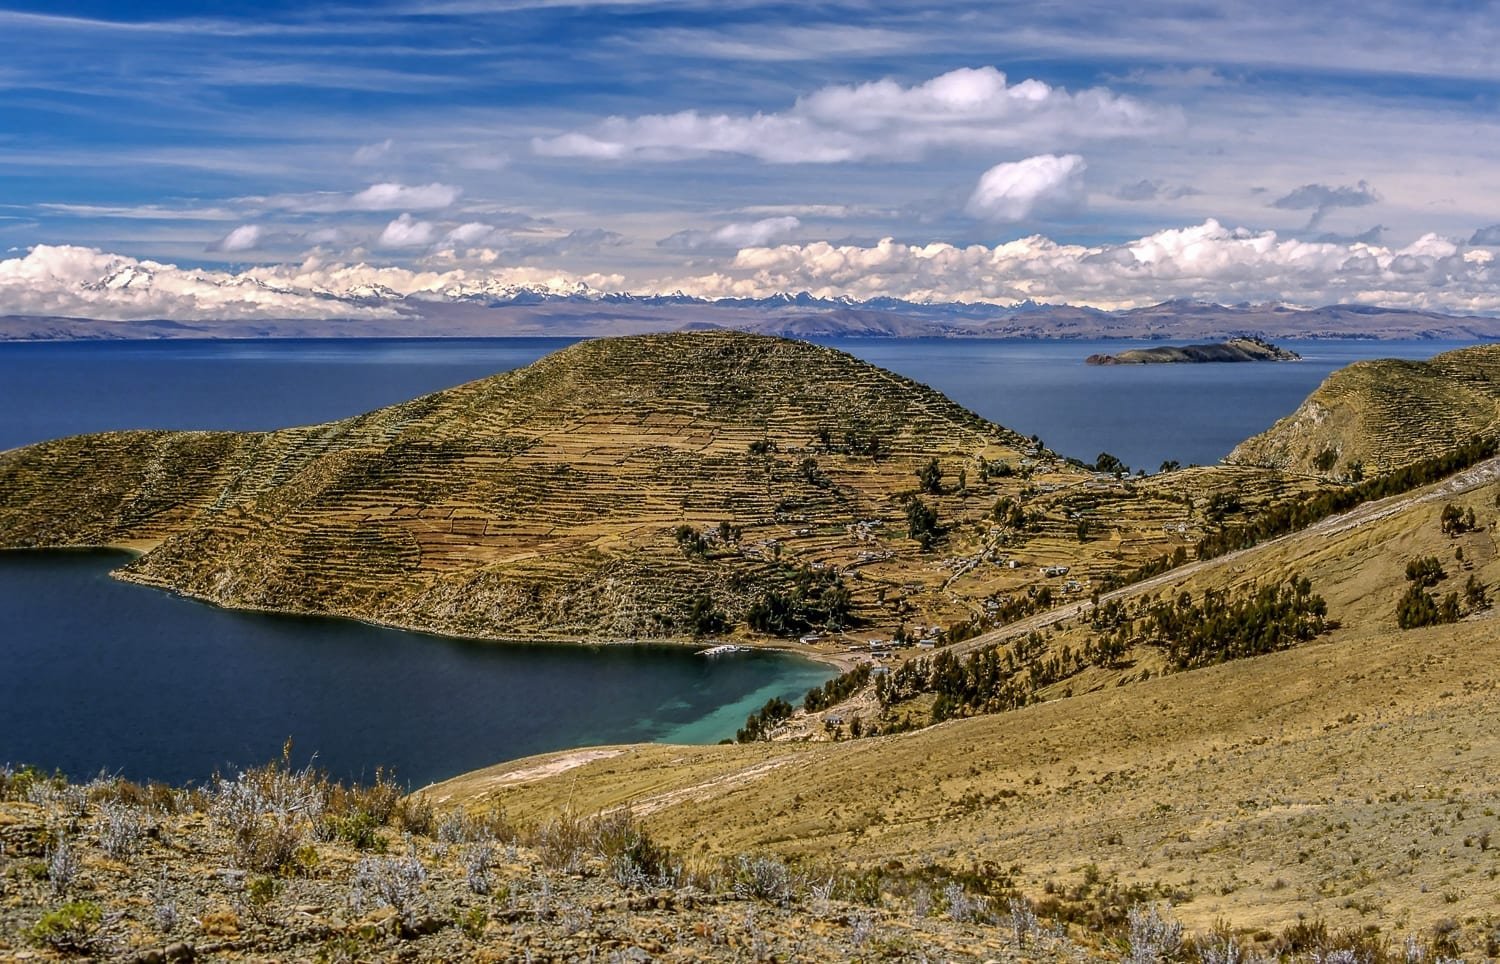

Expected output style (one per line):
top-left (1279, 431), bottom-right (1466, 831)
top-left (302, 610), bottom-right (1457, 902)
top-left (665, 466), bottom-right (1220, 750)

top-left (0, 339), bottom-right (1476, 784)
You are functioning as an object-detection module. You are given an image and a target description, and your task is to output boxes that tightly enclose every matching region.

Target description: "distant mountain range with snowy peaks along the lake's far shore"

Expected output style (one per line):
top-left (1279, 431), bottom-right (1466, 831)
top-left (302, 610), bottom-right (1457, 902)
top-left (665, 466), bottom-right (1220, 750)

top-left (0, 286), bottom-right (1500, 340)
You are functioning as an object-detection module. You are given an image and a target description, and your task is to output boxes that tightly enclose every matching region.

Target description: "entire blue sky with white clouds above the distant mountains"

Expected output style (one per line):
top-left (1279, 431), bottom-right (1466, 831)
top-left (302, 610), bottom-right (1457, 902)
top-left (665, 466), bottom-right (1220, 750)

top-left (0, 0), bottom-right (1500, 318)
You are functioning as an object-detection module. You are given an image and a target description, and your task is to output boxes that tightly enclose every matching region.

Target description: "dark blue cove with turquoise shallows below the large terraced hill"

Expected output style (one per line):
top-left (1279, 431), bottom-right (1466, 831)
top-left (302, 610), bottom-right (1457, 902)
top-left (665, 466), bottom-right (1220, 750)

top-left (0, 552), bottom-right (834, 787)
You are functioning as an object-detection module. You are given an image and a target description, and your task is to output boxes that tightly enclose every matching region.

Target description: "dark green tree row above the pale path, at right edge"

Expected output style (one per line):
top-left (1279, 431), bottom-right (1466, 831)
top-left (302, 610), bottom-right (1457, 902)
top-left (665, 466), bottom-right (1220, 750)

top-left (1199, 438), bottom-right (1496, 559)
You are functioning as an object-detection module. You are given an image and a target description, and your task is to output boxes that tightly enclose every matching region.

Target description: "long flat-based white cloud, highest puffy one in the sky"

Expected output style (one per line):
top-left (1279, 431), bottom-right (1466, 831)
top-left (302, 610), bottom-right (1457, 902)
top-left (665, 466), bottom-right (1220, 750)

top-left (533, 67), bottom-right (1176, 163)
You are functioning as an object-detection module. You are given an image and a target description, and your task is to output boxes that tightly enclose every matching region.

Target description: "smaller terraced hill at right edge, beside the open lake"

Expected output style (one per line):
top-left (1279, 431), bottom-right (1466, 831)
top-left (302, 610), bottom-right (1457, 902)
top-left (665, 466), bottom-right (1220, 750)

top-left (1229, 345), bottom-right (1500, 477)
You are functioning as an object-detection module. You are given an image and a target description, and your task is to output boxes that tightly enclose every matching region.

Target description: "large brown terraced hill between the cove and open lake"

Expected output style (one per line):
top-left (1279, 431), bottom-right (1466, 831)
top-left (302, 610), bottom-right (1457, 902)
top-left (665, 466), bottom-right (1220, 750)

top-left (0, 333), bottom-right (1286, 640)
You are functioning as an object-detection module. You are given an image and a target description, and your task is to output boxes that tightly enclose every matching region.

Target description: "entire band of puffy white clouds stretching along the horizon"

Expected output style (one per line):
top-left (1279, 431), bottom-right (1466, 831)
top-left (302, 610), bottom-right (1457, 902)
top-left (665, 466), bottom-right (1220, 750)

top-left (0, 219), bottom-right (1500, 321)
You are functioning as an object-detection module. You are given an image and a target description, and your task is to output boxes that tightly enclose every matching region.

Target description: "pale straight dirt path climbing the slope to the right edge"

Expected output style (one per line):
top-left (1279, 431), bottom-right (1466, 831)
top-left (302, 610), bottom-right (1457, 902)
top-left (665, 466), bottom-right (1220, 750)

top-left (948, 456), bottom-right (1500, 655)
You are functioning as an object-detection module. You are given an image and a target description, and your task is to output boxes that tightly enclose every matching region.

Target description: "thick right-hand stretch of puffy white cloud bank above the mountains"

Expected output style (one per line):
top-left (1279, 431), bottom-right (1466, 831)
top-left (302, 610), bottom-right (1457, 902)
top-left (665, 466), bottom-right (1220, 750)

top-left (671, 220), bottom-right (1500, 312)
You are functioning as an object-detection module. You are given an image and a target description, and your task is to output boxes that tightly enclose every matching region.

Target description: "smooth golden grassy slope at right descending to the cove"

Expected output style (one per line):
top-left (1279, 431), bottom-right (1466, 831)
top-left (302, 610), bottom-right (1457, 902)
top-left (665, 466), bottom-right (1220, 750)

top-left (434, 471), bottom-right (1500, 957)
